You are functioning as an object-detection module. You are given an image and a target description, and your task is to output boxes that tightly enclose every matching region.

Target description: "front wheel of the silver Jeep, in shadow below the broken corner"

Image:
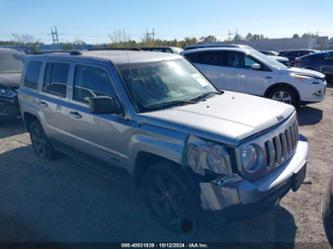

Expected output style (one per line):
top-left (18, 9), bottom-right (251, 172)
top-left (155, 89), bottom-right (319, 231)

top-left (143, 162), bottom-right (200, 235)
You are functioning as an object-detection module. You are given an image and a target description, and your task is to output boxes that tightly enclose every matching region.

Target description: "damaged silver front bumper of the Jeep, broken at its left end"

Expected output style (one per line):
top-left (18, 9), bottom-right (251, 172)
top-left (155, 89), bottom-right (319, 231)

top-left (200, 137), bottom-right (308, 216)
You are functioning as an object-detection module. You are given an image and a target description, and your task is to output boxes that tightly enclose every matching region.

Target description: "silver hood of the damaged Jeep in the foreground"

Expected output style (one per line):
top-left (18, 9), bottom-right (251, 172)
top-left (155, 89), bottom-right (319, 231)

top-left (138, 91), bottom-right (295, 145)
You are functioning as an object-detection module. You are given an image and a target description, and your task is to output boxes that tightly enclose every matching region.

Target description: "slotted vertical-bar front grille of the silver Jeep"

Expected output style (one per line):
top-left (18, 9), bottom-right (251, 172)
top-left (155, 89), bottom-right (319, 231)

top-left (264, 120), bottom-right (299, 168)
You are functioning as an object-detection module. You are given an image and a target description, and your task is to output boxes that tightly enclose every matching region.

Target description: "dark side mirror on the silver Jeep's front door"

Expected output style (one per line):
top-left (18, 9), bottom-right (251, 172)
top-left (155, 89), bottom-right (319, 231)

top-left (89, 96), bottom-right (123, 114)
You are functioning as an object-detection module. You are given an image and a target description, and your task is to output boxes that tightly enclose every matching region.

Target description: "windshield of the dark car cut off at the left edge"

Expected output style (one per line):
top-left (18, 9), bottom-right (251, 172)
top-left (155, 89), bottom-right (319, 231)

top-left (0, 50), bottom-right (23, 74)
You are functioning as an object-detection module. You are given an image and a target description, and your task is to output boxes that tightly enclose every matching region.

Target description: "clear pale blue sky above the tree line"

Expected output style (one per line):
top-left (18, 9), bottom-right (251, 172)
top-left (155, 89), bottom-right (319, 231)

top-left (0, 0), bottom-right (333, 43)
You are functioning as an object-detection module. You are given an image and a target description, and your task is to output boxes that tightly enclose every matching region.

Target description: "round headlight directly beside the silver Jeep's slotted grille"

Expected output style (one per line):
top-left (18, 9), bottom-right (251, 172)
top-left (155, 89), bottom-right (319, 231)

top-left (239, 144), bottom-right (265, 174)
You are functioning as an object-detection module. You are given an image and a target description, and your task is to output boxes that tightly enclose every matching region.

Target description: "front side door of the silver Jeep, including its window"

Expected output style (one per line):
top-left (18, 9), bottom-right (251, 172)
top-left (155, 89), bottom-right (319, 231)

top-left (66, 64), bottom-right (128, 167)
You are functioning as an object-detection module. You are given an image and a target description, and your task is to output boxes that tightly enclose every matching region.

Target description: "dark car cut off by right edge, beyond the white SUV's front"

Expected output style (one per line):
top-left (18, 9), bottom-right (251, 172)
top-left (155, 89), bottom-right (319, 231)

top-left (295, 51), bottom-right (333, 80)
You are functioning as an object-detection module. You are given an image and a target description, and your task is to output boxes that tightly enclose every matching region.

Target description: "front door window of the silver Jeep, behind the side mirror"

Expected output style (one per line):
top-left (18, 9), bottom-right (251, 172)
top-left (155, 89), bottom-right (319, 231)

top-left (73, 65), bottom-right (115, 102)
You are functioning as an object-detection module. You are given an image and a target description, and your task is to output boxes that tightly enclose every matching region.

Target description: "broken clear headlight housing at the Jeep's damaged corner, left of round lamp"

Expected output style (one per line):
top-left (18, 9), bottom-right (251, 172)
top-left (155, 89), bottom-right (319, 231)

top-left (185, 136), bottom-right (232, 175)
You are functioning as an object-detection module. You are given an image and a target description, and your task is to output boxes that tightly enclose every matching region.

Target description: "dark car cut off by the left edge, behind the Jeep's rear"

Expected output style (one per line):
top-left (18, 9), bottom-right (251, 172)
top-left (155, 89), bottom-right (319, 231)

top-left (0, 48), bottom-right (24, 121)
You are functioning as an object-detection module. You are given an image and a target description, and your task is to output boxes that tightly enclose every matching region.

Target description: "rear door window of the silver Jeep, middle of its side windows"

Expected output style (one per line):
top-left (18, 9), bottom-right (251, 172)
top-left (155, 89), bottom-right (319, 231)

top-left (43, 63), bottom-right (69, 97)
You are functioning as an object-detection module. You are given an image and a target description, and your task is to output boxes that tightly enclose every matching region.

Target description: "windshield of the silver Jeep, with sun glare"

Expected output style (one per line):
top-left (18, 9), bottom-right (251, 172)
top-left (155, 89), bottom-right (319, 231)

top-left (120, 59), bottom-right (219, 112)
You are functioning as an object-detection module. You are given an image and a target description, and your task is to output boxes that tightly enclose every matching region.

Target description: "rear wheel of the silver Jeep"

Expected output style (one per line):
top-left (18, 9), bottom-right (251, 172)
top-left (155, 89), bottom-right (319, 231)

top-left (29, 121), bottom-right (56, 161)
